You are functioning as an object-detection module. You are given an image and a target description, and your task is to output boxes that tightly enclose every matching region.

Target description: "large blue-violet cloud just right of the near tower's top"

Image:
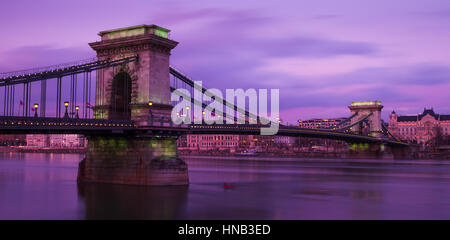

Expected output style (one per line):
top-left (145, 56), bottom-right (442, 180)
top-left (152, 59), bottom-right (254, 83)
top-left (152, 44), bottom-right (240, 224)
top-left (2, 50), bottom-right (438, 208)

top-left (165, 6), bottom-right (379, 95)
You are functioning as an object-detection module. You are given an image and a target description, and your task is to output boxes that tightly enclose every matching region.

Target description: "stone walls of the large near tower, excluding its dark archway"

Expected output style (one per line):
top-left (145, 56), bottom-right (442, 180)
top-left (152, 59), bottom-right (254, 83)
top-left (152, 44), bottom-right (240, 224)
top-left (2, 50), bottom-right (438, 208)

top-left (90, 26), bottom-right (178, 126)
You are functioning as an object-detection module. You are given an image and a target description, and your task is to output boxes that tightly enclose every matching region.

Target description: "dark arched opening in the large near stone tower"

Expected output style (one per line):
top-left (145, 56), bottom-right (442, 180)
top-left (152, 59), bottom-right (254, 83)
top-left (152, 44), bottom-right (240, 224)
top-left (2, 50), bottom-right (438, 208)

top-left (109, 71), bottom-right (131, 120)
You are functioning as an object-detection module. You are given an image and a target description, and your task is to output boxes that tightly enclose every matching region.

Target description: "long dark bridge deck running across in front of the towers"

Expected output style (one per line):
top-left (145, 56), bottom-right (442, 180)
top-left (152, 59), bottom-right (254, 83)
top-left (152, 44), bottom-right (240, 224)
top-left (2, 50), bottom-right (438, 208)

top-left (0, 117), bottom-right (408, 146)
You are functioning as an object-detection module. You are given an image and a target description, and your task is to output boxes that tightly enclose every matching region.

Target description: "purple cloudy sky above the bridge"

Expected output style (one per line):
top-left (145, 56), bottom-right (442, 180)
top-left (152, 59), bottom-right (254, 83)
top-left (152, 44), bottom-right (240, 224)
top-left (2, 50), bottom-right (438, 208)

top-left (0, 0), bottom-right (450, 122)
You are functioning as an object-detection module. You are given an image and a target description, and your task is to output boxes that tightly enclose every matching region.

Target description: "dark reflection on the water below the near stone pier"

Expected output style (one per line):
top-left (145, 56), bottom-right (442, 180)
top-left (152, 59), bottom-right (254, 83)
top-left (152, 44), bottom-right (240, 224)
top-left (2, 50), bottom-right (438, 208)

top-left (78, 183), bottom-right (188, 219)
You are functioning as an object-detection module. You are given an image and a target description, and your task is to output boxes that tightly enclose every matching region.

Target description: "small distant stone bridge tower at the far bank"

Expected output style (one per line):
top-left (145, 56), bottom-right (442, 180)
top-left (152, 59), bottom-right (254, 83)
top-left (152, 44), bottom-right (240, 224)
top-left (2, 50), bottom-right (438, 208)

top-left (348, 101), bottom-right (383, 137)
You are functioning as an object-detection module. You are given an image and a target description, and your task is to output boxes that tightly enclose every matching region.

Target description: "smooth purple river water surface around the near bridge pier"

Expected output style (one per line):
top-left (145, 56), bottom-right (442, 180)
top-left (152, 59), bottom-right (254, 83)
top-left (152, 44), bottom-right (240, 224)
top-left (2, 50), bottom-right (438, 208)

top-left (0, 153), bottom-right (450, 219)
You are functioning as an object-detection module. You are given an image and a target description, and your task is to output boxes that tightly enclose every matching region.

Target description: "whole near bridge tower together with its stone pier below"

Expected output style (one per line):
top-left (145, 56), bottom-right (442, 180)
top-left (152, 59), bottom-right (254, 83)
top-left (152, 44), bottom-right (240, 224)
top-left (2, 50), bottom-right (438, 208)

top-left (78, 25), bottom-right (189, 185)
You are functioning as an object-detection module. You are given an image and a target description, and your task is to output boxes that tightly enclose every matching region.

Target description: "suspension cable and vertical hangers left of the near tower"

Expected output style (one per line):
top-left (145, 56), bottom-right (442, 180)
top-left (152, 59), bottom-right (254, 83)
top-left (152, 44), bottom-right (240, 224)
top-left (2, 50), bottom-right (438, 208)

top-left (0, 56), bottom-right (138, 118)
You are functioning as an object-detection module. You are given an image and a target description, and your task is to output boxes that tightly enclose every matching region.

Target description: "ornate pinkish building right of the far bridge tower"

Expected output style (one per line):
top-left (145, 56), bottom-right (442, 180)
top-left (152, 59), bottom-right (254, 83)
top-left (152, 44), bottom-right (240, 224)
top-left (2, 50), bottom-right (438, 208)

top-left (388, 108), bottom-right (450, 144)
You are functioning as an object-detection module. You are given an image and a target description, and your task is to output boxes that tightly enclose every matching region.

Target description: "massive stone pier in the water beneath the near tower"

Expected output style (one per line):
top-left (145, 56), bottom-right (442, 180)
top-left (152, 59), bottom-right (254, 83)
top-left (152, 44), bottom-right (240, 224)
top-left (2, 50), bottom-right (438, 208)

top-left (78, 136), bottom-right (189, 186)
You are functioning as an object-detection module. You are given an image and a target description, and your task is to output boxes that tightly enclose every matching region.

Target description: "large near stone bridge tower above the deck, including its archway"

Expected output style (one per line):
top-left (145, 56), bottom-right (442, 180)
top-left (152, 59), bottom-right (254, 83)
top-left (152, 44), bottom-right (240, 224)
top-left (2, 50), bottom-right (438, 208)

top-left (89, 25), bottom-right (178, 126)
